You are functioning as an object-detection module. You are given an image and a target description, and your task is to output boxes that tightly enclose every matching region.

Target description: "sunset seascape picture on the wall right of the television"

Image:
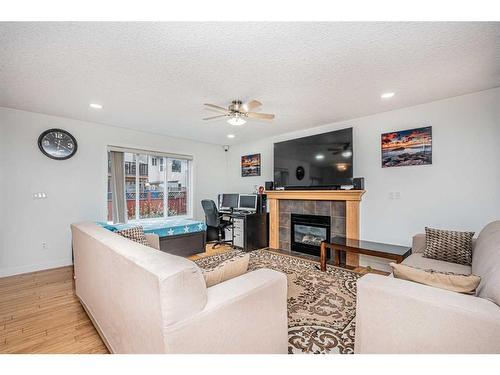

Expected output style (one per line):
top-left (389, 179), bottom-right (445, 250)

top-left (382, 126), bottom-right (432, 168)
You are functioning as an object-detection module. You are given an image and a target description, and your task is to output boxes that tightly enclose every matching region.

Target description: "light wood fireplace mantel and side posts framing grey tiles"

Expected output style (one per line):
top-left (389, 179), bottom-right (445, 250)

top-left (266, 190), bottom-right (365, 267)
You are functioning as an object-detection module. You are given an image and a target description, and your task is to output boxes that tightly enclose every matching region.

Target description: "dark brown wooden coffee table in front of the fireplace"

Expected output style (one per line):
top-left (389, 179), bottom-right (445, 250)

top-left (319, 237), bottom-right (411, 272)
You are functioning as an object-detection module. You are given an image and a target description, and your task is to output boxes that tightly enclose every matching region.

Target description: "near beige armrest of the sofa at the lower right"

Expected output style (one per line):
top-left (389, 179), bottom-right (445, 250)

top-left (354, 274), bottom-right (500, 353)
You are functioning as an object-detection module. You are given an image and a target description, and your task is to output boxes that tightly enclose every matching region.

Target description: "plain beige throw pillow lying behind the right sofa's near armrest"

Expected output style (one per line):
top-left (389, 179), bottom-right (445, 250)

top-left (389, 263), bottom-right (481, 294)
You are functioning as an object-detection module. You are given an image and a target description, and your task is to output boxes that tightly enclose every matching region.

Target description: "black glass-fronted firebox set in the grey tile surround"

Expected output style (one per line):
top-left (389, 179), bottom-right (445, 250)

top-left (290, 213), bottom-right (331, 256)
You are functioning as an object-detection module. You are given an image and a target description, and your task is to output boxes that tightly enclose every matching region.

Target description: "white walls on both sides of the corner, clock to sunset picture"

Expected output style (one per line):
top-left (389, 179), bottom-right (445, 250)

top-left (0, 88), bottom-right (500, 276)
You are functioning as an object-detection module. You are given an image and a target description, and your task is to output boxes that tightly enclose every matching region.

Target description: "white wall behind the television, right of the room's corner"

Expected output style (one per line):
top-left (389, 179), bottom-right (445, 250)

top-left (227, 88), bottom-right (500, 251)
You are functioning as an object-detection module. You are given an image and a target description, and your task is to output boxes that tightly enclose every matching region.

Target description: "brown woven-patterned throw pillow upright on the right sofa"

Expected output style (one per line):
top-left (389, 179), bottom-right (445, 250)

top-left (423, 227), bottom-right (474, 266)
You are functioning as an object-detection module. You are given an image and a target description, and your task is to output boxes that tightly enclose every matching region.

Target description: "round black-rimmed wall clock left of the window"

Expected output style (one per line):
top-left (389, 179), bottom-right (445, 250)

top-left (38, 129), bottom-right (78, 160)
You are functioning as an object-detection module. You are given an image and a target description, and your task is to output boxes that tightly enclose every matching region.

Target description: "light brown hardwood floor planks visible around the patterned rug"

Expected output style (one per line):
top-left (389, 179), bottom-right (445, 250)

top-left (0, 245), bottom-right (384, 354)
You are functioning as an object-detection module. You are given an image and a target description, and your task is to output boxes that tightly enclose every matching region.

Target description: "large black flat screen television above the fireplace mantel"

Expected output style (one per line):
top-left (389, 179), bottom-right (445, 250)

top-left (274, 128), bottom-right (353, 189)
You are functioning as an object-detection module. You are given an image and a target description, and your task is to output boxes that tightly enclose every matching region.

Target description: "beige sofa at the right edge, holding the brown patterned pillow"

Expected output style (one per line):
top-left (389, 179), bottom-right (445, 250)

top-left (354, 221), bottom-right (500, 353)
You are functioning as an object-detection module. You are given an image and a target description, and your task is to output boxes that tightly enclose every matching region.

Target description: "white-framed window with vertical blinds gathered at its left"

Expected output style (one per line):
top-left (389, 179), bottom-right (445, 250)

top-left (108, 152), bottom-right (192, 221)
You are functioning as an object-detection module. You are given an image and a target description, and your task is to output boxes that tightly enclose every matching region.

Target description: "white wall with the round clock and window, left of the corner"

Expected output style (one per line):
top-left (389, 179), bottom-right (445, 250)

top-left (0, 108), bottom-right (225, 276)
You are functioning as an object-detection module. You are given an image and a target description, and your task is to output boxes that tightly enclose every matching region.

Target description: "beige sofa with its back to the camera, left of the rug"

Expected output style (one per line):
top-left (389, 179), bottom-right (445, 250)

top-left (71, 222), bottom-right (288, 353)
